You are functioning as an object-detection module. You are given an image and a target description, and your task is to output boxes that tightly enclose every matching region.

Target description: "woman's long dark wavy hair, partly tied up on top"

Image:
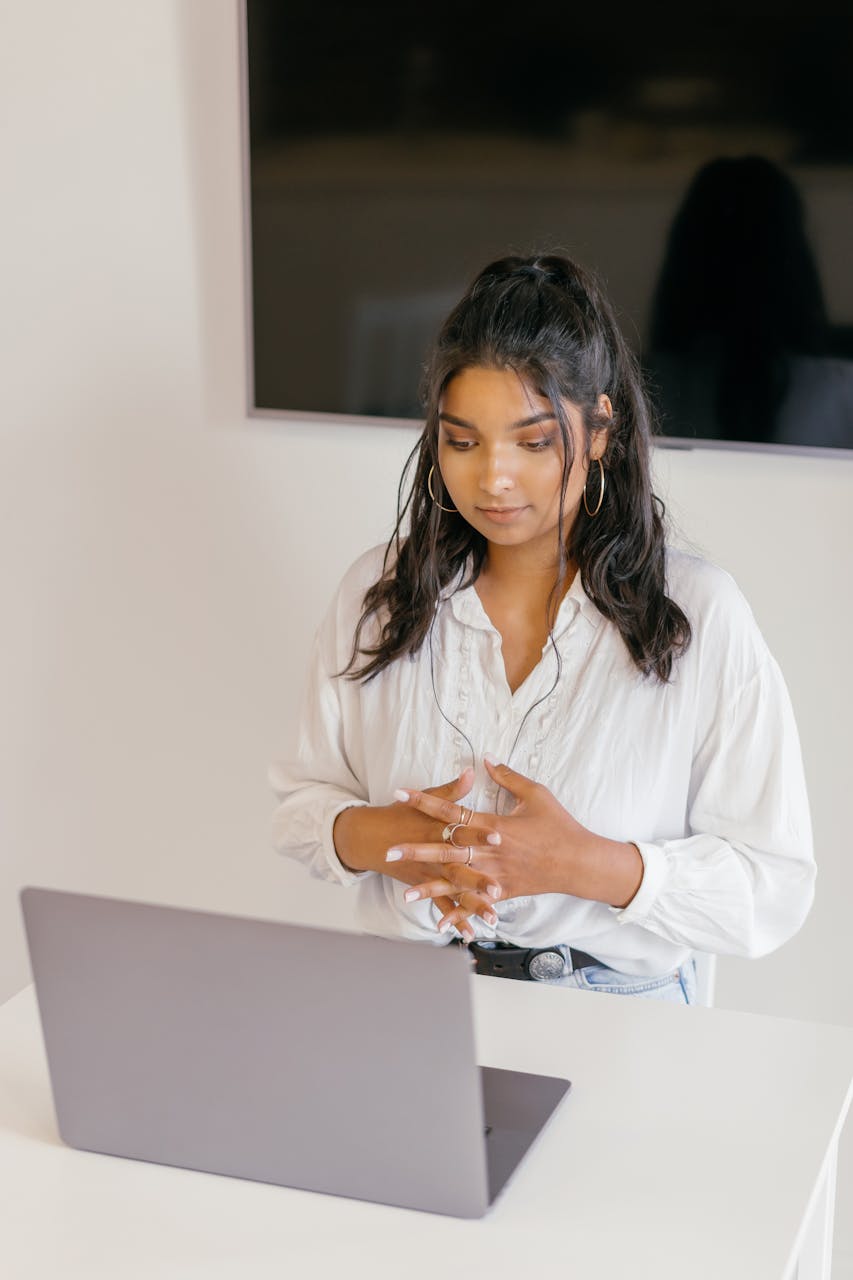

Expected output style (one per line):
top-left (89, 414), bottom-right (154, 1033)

top-left (343, 255), bottom-right (690, 681)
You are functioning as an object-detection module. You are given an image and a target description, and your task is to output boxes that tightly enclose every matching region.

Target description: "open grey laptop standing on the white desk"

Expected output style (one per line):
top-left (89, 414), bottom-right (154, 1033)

top-left (20, 888), bottom-right (570, 1217)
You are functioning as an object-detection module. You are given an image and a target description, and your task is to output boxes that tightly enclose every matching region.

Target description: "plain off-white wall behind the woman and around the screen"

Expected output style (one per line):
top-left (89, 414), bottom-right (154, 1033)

top-left (0, 0), bottom-right (853, 1259)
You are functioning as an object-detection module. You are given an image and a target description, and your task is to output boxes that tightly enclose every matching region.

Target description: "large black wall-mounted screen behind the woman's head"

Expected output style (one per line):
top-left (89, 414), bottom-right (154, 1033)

top-left (239, 0), bottom-right (853, 449)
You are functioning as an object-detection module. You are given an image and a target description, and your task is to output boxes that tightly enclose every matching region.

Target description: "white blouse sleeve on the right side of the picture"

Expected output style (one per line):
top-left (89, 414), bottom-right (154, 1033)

top-left (617, 645), bottom-right (815, 956)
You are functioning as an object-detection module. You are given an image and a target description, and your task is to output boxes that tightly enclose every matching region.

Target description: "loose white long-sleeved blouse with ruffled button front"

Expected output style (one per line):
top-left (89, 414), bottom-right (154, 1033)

top-left (270, 548), bottom-right (815, 975)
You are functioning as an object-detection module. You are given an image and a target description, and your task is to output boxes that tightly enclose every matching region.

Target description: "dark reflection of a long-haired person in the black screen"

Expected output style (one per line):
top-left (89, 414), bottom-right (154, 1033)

top-left (648, 156), bottom-right (853, 448)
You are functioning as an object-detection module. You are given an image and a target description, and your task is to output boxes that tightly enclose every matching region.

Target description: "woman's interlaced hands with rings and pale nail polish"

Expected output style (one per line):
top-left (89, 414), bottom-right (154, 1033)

top-left (386, 756), bottom-right (592, 941)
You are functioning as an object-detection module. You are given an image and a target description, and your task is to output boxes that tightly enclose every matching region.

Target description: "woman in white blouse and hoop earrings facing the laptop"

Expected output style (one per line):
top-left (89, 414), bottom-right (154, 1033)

top-left (272, 256), bottom-right (815, 1002)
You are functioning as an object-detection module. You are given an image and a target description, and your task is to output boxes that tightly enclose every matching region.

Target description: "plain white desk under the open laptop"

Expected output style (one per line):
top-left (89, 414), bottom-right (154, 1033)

top-left (0, 978), bottom-right (853, 1280)
